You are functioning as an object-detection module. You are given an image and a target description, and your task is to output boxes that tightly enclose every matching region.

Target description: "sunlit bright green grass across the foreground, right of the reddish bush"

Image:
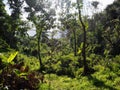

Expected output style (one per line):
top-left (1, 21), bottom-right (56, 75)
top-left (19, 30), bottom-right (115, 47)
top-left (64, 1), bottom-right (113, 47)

top-left (39, 65), bottom-right (120, 90)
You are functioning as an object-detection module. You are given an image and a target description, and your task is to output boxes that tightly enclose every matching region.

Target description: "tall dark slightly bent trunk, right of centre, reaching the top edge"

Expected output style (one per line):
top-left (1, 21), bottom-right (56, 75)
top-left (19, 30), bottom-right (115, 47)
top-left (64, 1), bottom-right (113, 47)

top-left (77, 0), bottom-right (88, 75)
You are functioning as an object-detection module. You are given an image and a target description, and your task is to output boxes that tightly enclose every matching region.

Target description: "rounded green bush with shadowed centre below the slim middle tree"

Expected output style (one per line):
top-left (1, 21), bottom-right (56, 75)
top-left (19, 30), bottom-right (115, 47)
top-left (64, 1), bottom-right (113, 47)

top-left (55, 53), bottom-right (78, 77)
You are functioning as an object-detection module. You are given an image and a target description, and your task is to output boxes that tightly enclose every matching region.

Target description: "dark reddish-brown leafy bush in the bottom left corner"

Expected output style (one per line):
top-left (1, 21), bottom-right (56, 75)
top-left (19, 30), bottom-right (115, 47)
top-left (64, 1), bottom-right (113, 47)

top-left (0, 64), bottom-right (44, 90)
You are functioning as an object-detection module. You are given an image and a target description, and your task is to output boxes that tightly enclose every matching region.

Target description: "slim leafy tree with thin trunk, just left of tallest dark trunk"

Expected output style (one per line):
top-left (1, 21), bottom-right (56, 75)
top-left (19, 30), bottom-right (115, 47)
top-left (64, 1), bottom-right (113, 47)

top-left (61, 14), bottom-right (79, 56)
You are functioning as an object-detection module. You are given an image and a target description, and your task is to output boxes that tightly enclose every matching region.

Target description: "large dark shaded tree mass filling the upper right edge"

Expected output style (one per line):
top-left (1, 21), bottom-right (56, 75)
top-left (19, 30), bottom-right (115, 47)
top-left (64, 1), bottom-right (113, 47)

top-left (88, 0), bottom-right (120, 56)
